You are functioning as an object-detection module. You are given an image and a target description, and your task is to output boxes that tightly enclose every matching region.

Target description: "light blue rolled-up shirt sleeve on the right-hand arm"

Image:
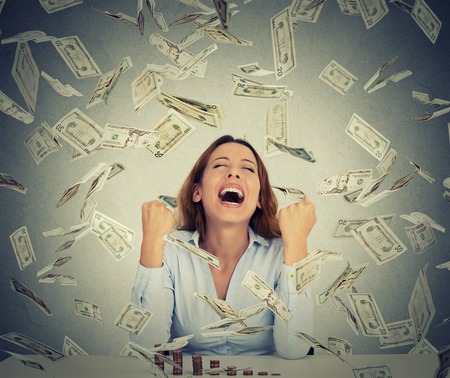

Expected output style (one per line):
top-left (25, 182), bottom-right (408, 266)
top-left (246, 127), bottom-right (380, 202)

top-left (274, 264), bottom-right (314, 359)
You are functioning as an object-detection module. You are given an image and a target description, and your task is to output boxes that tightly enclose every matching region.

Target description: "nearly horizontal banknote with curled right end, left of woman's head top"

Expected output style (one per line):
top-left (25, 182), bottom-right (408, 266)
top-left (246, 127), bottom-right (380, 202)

top-left (101, 123), bottom-right (159, 150)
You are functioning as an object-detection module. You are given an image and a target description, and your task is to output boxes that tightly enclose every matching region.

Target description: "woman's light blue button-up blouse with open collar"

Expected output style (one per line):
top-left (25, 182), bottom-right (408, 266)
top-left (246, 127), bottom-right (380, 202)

top-left (130, 228), bottom-right (314, 359)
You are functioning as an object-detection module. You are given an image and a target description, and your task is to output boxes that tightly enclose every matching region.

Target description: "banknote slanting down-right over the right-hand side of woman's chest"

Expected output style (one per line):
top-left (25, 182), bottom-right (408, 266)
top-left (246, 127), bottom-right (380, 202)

top-left (241, 270), bottom-right (292, 322)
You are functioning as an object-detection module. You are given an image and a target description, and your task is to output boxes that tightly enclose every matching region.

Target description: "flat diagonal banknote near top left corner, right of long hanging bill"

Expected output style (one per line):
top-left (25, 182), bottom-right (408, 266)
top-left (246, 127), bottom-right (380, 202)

top-left (51, 36), bottom-right (102, 79)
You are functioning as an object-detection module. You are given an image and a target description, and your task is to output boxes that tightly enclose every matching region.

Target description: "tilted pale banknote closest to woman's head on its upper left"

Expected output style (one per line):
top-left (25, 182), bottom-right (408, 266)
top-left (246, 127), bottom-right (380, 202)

top-left (147, 109), bottom-right (196, 157)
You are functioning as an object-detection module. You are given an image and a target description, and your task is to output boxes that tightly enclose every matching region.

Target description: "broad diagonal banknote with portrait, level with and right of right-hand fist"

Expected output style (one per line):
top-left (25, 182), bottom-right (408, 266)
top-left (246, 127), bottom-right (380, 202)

top-left (351, 217), bottom-right (408, 265)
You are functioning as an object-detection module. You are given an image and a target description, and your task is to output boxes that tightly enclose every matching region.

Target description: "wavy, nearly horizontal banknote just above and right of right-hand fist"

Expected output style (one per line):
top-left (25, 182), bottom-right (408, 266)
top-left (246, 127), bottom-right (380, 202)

top-left (317, 169), bottom-right (372, 196)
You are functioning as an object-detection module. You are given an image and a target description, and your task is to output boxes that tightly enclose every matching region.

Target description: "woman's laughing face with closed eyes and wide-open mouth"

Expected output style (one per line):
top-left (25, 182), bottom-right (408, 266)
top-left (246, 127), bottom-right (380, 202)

top-left (193, 142), bottom-right (260, 229)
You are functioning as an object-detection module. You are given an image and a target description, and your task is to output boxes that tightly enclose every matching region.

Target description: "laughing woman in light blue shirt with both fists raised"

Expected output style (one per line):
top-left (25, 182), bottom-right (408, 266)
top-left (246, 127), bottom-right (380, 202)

top-left (132, 135), bottom-right (316, 359)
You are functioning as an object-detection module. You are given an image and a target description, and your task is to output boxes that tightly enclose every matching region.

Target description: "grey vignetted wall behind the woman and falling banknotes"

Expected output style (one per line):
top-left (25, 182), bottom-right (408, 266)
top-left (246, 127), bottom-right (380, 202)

top-left (0, 0), bottom-right (450, 358)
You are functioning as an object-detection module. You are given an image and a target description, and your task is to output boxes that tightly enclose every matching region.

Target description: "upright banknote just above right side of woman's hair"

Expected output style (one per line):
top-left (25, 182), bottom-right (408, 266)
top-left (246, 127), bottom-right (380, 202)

top-left (264, 101), bottom-right (289, 157)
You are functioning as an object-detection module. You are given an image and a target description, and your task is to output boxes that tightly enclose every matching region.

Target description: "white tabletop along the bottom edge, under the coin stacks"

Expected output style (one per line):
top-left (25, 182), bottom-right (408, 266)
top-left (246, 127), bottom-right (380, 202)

top-left (0, 354), bottom-right (439, 378)
